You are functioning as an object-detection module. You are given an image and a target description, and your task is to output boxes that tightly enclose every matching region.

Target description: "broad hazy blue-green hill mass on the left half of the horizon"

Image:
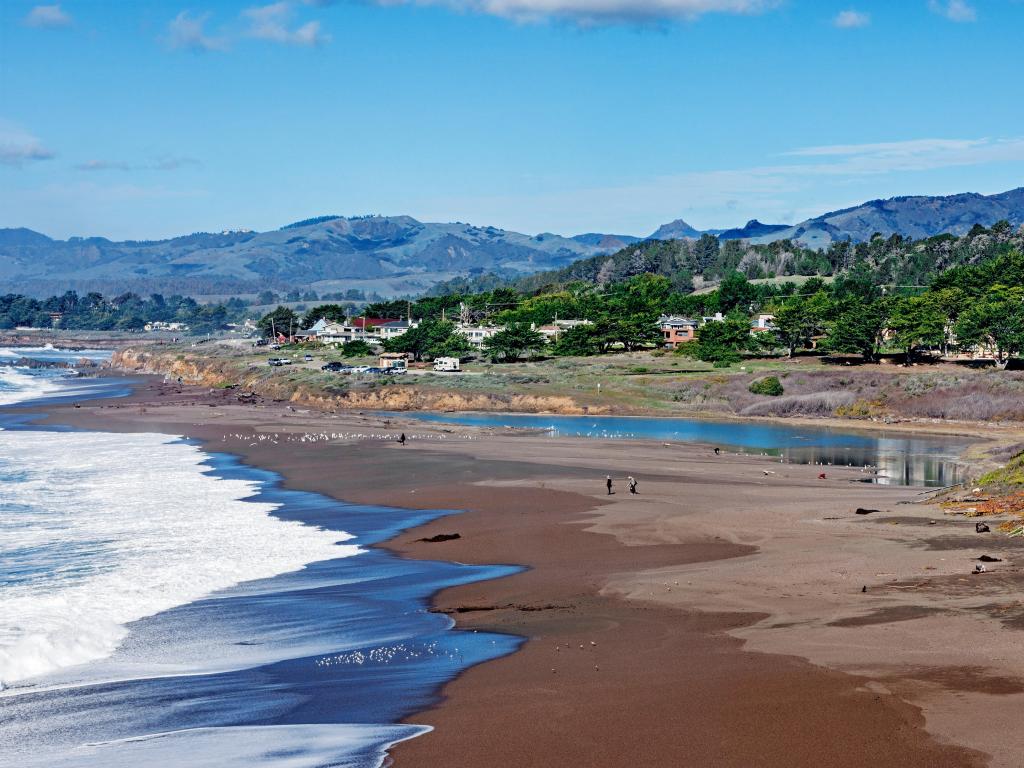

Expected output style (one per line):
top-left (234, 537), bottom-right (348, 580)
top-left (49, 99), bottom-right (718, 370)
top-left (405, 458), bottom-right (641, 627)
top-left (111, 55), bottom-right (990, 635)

top-left (0, 216), bottom-right (614, 296)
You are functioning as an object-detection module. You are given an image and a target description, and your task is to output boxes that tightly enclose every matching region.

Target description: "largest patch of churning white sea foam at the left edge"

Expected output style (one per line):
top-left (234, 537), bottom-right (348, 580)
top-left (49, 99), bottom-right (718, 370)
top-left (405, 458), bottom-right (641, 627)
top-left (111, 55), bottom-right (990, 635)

top-left (0, 431), bottom-right (359, 684)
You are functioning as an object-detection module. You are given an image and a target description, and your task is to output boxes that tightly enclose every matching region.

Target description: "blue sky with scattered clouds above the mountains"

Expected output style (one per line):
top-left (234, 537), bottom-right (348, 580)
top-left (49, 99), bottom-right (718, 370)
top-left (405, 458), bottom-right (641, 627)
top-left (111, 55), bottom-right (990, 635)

top-left (0, 0), bottom-right (1024, 239)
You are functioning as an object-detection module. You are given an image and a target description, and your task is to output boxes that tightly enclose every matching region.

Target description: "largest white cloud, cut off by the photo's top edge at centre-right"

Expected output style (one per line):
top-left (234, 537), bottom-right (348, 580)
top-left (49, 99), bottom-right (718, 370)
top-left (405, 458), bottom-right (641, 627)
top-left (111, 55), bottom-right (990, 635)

top-left (375, 0), bottom-right (780, 27)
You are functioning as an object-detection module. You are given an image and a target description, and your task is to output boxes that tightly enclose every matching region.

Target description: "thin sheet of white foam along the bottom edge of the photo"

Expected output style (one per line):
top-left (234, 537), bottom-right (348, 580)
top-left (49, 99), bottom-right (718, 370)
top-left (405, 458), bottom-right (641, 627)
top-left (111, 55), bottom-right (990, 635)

top-left (19, 725), bottom-right (430, 768)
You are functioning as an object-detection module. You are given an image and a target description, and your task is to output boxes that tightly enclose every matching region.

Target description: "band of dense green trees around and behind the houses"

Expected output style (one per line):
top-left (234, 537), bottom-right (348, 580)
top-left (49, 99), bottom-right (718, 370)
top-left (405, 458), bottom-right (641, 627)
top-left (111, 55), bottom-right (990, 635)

top-left (268, 248), bottom-right (1024, 366)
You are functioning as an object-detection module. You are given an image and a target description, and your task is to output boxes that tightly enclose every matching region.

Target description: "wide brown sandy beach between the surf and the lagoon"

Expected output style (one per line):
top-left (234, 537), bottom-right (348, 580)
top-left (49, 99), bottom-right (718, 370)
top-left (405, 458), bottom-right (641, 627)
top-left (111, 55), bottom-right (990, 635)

top-left (32, 378), bottom-right (1024, 767)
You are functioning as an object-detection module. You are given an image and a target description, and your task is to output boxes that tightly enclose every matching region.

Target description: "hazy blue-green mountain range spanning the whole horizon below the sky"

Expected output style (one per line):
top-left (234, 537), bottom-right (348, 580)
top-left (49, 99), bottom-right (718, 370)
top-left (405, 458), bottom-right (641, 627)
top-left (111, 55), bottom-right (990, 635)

top-left (0, 187), bottom-right (1024, 296)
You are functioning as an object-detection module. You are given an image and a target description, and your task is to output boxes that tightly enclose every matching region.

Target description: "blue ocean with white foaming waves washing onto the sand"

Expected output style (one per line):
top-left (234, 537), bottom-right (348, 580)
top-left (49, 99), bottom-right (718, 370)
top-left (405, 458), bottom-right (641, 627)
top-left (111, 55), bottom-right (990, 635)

top-left (0, 348), bottom-right (521, 768)
